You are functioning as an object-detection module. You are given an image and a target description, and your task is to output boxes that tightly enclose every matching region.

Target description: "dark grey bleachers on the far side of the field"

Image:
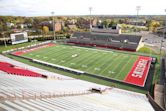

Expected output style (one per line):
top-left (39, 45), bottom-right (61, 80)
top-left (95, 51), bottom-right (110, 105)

top-left (67, 32), bottom-right (141, 51)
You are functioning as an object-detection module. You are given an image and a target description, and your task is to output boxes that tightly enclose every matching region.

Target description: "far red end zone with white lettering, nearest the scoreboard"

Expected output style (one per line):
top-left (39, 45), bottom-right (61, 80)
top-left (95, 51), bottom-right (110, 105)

top-left (12, 43), bottom-right (55, 55)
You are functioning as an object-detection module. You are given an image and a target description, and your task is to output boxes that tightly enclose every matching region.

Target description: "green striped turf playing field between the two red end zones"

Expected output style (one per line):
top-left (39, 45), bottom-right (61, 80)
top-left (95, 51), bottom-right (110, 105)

top-left (22, 45), bottom-right (138, 80)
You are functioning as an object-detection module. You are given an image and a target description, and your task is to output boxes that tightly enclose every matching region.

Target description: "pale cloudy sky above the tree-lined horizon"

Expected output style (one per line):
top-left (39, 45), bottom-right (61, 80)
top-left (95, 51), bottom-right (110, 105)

top-left (0, 0), bottom-right (166, 16)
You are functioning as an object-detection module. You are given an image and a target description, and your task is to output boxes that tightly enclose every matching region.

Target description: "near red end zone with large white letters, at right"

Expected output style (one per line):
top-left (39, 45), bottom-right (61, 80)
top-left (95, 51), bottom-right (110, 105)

top-left (124, 56), bottom-right (152, 87)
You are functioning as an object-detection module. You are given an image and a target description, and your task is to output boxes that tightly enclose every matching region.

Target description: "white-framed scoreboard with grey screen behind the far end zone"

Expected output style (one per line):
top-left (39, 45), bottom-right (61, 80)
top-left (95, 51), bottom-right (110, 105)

top-left (10, 32), bottom-right (28, 44)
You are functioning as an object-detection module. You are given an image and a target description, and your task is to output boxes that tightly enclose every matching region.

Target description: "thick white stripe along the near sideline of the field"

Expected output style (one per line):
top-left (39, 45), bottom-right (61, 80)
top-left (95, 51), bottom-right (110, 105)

top-left (32, 59), bottom-right (84, 74)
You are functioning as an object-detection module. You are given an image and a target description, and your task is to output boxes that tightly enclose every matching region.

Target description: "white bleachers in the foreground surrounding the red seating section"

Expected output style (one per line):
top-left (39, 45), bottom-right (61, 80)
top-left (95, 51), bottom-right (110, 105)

top-left (0, 55), bottom-right (154, 111)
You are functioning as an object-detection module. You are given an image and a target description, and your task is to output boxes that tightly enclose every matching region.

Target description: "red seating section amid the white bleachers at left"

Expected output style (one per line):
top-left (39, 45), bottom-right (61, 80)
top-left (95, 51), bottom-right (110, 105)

top-left (0, 62), bottom-right (42, 77)
